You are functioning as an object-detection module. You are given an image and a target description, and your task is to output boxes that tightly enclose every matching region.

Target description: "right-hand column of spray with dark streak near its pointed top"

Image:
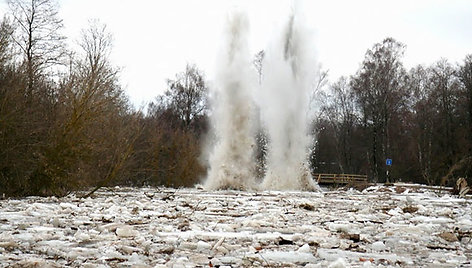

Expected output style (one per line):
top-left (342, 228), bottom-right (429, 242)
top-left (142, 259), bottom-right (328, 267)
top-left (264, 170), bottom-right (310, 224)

top-left (259, 11), bottom-right (319, 191)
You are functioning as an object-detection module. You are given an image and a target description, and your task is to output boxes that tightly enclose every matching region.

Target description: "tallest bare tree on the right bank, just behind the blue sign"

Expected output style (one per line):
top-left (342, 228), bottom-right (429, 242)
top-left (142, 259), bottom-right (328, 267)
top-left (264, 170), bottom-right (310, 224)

top-left (351, 38), bottom-right (407, 182)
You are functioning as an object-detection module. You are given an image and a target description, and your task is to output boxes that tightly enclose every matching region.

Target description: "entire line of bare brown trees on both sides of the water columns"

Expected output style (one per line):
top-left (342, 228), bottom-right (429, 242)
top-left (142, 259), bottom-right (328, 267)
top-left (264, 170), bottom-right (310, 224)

top-left (0, 0), bottom-right (472, 196)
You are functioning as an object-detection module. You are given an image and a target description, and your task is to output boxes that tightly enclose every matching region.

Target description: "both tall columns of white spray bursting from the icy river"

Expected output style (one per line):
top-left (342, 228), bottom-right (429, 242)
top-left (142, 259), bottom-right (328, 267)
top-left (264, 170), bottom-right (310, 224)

top-left (205, 5), bottom-right (319, 191)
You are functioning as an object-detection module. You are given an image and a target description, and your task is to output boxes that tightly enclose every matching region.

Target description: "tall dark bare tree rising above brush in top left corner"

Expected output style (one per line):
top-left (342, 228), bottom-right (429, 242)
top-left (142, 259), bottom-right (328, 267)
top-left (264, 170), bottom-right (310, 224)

top-left (7, 0), bottom-right (66, 94)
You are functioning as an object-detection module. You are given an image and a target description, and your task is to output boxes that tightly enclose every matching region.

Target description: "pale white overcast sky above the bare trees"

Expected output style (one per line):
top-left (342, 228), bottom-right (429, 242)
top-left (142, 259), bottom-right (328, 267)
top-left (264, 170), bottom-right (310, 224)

top-left (0, 0), bottom-right (472, 107)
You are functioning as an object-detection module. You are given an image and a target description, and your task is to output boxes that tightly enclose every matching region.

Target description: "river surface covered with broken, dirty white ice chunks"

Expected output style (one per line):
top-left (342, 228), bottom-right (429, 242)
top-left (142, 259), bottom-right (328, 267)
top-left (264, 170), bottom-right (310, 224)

top-left (0, 185), bottom-right (472, 267)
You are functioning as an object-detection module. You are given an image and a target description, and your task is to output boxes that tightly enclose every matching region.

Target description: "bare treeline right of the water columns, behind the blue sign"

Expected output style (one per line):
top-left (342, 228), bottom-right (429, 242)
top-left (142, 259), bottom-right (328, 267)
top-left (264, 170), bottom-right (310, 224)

top-left (313, 38), bottom-right (472, 185)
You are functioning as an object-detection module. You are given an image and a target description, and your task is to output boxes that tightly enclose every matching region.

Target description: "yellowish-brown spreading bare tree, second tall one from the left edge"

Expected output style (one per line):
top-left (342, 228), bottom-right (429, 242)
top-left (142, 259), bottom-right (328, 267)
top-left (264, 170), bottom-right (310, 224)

top-left (63, 21), bottom-right (131, 186)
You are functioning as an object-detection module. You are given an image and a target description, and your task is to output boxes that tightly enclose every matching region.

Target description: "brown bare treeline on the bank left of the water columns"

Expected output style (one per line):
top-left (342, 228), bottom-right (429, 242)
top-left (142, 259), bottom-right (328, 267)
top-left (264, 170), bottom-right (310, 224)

top-left (0, 0), bottom-right (207, 196)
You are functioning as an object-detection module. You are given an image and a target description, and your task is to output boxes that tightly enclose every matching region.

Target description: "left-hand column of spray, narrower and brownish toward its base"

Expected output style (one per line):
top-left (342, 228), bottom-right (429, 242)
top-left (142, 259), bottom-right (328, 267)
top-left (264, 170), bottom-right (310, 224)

top-left (205, 12), bottom-right (256, 190)
